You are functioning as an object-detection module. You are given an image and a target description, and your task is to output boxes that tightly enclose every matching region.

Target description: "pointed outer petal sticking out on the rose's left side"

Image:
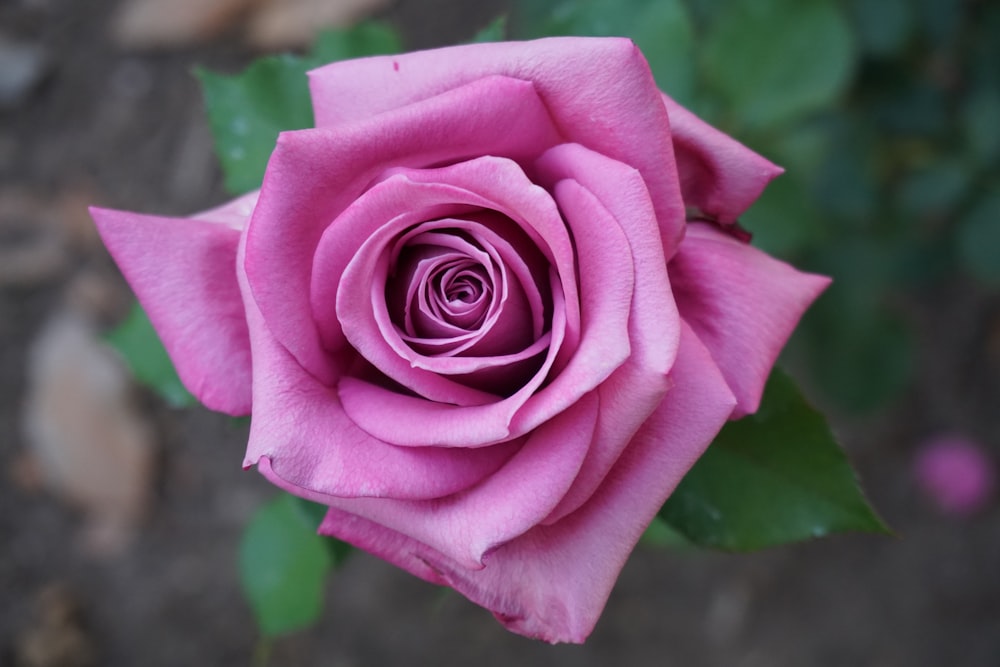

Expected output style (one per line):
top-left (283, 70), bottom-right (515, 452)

top-left (90, 193), bottom-right (256, 415)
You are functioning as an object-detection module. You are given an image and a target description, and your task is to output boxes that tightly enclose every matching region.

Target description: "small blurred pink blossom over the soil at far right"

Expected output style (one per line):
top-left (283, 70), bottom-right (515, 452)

top-left (914, 435), bottom-right (996, 516)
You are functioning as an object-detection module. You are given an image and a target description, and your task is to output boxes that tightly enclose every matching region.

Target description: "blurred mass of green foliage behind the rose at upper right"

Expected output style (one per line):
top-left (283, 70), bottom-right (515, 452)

top-left (512, 0), bottom-right (1000, 411)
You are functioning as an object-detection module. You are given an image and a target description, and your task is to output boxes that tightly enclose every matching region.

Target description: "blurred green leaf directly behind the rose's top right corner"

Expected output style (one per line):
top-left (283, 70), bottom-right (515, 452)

top-left (519, 0), bottom-right (695, 104)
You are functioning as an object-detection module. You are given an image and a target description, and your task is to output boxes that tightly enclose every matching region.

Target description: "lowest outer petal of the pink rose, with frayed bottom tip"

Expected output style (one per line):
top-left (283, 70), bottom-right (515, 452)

top-left (320, 327), bottom-right (735, 643)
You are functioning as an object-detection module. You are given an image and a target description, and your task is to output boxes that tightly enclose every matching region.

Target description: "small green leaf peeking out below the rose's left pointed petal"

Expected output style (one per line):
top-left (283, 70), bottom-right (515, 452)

top-left (107, 302), bottom-right (198, 408)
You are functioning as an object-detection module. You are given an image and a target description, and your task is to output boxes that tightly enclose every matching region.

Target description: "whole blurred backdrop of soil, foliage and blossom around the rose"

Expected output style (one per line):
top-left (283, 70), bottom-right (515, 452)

top-left (0, 0), bottom-right (1000, 667)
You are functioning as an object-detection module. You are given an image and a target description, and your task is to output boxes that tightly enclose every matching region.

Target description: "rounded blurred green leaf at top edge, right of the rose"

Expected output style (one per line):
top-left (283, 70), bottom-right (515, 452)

top-left (703, 0), bottom-right (855, 127)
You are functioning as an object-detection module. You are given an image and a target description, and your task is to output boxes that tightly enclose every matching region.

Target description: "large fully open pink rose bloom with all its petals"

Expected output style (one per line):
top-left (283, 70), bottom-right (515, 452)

top-left (93, 38), bottom-right (828, 642)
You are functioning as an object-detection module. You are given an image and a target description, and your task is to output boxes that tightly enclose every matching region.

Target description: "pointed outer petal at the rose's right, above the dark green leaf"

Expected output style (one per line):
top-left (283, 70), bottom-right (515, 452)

top-left (669, 223), bottom-right (830, 419)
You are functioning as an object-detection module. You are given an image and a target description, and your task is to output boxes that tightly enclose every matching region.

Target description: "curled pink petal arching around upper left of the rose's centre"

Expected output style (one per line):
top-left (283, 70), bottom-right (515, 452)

top-left (246, 75), bottom-right (559, 383)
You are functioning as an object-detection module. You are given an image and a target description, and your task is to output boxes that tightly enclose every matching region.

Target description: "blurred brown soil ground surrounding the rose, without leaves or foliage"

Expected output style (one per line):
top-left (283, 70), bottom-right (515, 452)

top-left (0, 0), bottom-right (1000, 667)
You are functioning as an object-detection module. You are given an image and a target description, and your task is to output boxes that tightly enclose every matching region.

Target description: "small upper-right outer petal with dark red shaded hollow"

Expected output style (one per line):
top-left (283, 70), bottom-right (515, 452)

top-left (663, 95), bottom-right (784, 224)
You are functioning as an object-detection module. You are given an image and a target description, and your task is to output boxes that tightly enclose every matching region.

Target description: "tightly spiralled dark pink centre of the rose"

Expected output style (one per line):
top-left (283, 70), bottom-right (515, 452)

top-left (385, 211), bottom-right (552, 390)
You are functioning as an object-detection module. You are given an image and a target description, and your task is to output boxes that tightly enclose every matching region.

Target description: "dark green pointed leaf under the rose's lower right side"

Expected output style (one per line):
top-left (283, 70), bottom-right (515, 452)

top-left (660, 370), bottom-right (888, 551)
